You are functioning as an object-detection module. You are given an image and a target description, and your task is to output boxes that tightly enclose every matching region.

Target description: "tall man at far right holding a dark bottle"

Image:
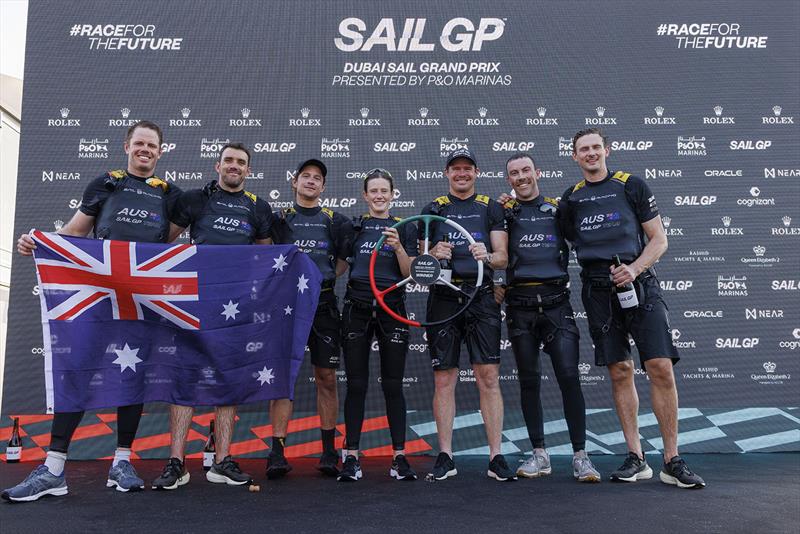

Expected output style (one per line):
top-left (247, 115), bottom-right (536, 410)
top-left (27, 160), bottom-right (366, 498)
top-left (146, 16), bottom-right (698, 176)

top-left (560, 128), bottom-right (705, 488)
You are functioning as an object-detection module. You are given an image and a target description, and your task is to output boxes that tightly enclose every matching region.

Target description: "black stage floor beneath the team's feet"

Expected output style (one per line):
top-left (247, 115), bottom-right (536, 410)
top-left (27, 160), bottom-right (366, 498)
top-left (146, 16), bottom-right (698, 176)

top-left (0, 453), bottom-right (800, 534)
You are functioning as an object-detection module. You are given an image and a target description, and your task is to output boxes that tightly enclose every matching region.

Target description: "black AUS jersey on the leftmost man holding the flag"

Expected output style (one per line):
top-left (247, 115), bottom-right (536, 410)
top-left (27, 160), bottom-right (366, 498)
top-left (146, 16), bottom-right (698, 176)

top-left (80, 169), bottom-right (181, 243)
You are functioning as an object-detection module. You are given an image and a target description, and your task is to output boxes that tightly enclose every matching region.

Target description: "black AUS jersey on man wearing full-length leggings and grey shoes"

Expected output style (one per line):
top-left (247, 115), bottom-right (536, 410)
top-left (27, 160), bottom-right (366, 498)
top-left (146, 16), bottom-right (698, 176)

top-left (504, 195), bottom-right (569, 285)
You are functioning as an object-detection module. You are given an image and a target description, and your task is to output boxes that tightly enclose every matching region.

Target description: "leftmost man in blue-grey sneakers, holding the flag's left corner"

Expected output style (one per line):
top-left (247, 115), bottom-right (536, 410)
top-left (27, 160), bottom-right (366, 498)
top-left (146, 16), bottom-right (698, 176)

top-left (2, 121), bottom-right (180, 501)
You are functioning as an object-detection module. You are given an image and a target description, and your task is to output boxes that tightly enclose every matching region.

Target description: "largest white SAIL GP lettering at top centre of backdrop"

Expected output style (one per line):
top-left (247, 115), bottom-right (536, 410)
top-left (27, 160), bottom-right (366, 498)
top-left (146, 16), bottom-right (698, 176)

top-left (333, 17), bottom-right (506, 52)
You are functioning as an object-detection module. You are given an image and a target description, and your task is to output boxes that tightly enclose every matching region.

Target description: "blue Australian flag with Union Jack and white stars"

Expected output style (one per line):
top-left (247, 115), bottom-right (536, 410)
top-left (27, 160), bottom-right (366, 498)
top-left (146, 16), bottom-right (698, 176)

top-left (32, 230), bottom-right (321, 413)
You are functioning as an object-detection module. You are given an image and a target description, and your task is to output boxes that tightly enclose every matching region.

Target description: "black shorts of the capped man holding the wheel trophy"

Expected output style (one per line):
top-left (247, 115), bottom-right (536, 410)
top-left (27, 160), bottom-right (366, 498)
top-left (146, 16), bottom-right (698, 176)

top-left (426, 286), bottom-right (500, 371)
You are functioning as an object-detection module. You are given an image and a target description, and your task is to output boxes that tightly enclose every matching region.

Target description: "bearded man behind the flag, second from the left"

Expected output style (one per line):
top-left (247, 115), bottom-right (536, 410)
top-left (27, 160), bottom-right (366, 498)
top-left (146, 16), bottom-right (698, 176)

top-left (148, 143), bottom-right (272, 490)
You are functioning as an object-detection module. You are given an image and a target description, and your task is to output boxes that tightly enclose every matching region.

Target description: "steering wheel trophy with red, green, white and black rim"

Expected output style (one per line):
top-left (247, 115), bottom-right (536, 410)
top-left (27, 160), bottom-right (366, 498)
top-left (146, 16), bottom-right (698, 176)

top-left (369, 215), bottom-right (483, 327)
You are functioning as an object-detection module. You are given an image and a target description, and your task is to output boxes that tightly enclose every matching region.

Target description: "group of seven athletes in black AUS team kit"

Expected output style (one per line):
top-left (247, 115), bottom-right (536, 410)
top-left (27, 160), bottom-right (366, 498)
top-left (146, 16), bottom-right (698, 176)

top-left (0, 121), bottom-right (705, 502)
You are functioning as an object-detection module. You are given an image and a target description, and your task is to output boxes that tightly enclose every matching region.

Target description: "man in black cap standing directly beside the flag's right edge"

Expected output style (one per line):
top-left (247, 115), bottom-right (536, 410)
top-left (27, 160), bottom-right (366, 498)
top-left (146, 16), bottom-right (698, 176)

top-left (267, 159), bottom-right (353, 478)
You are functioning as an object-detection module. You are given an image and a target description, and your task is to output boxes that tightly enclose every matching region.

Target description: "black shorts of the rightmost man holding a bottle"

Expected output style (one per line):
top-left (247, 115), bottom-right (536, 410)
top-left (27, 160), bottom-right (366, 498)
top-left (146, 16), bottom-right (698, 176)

top-left (581, 275), bottom-right (680, 368)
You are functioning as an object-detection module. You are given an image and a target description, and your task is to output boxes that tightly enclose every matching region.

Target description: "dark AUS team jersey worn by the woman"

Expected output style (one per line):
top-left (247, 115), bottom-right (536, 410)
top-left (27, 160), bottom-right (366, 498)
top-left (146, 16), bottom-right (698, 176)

top-left (348, 214), bottom-right (417, 300)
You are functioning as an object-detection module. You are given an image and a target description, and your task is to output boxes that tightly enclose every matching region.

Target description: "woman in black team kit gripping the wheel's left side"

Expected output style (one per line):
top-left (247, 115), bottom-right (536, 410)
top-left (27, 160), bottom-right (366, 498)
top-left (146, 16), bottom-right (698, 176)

top-left (338, 169), bottom-right (417, 481)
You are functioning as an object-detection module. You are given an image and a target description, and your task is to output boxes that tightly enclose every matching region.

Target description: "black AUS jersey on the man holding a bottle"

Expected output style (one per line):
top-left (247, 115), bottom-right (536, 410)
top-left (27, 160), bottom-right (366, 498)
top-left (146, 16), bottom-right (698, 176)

top-left (559, 171), bottom-right (658, 268)
